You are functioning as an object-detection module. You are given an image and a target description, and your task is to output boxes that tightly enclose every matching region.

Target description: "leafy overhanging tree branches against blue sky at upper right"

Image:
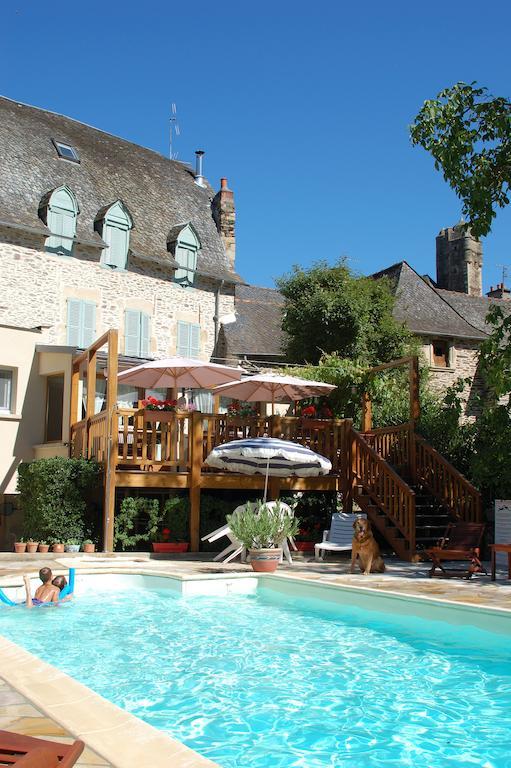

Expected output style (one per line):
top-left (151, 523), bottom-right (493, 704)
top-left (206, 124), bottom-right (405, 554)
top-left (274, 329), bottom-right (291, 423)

top-left (410, 82), bottom-right (511, 237)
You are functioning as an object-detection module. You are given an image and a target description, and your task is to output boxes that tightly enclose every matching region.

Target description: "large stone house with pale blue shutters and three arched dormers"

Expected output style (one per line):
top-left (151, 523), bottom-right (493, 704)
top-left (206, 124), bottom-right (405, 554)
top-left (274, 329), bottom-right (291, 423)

top-left (0, 98), bottom-right (243, 532)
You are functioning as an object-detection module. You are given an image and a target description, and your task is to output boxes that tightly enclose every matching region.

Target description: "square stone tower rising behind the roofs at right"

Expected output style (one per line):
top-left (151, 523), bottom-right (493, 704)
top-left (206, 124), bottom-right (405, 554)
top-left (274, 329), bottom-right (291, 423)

top-left (436, 222), bottom-right (483, 296)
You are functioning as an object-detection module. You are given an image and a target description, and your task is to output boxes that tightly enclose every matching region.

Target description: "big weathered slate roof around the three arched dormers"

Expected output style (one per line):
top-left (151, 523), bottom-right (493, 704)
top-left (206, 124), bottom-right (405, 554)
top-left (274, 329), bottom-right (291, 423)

top-left (0, 97), bottom-right (241, 282)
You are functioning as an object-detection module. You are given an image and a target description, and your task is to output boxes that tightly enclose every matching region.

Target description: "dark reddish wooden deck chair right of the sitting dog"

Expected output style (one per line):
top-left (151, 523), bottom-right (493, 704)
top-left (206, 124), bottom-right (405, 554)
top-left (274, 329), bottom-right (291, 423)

top-left (426, 522), bottom-right (488, 579)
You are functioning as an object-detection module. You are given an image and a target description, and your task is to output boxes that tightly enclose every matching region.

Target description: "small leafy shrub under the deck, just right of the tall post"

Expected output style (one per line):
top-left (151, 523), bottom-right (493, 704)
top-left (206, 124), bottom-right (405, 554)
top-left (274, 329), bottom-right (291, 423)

top-left (114, 496), bottom-right (162, 552)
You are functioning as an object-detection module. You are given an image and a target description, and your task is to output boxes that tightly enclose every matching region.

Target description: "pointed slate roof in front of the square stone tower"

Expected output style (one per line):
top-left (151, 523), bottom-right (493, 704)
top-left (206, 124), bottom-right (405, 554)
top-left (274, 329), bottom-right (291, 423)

top-left (372, 261), bottom-right (487, 341)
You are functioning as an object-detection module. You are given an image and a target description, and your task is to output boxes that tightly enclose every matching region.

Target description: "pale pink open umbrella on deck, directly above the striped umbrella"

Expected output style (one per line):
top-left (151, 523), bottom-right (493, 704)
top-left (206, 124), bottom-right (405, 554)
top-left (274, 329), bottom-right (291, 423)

top-left (215, 373), bottom-right (336, 414)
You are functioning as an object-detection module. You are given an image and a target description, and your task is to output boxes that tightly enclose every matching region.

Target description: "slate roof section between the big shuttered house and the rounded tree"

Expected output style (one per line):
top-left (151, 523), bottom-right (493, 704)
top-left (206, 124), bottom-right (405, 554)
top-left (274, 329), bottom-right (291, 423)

top-left (223, 285), bottom-right (284, 359)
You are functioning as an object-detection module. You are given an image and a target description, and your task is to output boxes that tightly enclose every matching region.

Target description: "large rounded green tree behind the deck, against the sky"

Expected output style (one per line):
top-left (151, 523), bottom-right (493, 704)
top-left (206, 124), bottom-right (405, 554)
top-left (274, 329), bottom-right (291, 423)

top-left (277, 259), bottom-right (412, 365)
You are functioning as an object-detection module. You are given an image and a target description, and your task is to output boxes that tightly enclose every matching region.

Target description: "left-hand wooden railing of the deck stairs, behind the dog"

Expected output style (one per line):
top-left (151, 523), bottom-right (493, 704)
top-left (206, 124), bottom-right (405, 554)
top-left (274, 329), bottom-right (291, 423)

top-left (350, 430), bottom-right (415, 552)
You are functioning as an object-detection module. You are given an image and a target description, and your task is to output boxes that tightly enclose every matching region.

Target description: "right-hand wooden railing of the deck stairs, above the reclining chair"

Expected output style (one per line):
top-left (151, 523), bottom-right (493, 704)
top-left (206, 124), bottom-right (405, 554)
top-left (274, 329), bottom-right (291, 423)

top-left (415, 435), bottom-right (482, 523)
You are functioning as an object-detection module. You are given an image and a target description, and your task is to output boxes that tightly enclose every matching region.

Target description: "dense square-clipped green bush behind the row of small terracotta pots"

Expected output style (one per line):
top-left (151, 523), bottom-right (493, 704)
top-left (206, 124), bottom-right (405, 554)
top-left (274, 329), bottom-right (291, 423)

top-left (18, 456), bottom-right (101, 543)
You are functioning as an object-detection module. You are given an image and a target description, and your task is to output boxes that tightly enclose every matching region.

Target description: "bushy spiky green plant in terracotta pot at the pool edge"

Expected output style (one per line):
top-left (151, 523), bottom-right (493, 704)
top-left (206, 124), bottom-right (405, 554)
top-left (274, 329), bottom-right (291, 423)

top-left (227, 501), bottom-right (299, 573)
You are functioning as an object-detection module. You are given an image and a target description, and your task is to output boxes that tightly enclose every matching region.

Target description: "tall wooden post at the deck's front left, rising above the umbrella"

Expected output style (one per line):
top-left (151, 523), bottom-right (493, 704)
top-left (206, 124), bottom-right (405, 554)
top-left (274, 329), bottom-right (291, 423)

top-left (104, 330), bottom-right (119, 552)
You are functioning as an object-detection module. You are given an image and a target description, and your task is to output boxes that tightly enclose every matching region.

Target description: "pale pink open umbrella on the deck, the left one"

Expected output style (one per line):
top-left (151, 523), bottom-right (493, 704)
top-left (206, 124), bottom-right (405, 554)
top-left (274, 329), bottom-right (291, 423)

top-left (118, 357), bottom-right (243, 389)
